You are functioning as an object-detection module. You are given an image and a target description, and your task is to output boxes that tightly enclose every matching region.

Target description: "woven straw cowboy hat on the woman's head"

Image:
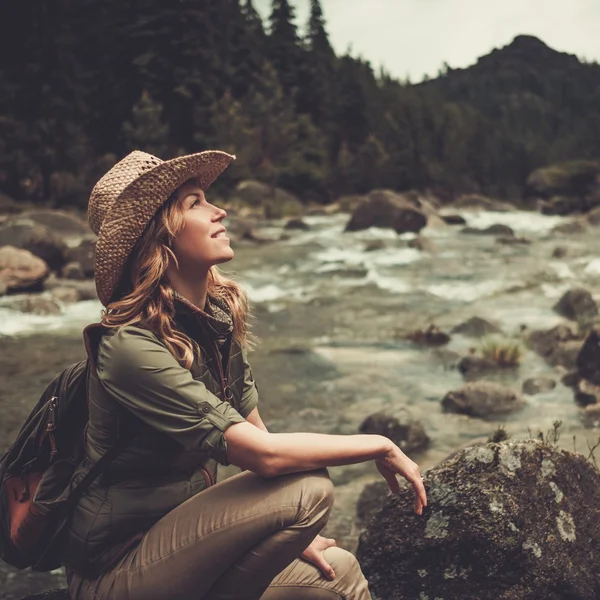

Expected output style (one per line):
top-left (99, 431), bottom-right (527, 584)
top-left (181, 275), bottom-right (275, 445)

top-left (88, 150), bottom-right (235, 306)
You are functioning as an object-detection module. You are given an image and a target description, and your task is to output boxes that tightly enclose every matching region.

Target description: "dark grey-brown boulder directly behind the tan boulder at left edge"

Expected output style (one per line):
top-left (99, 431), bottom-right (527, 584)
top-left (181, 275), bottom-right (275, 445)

top-left (0, 215), bottom-right (67, 271)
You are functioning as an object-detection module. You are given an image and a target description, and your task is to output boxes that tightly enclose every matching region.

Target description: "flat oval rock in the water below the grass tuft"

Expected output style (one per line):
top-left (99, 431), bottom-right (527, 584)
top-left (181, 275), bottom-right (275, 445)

top-left (442, 381), bottom-right (525, 418)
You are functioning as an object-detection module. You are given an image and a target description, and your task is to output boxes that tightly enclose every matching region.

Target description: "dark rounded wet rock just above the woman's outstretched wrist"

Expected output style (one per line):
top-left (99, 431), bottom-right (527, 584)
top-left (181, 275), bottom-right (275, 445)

top-left (359, 409), bottom-right (429, 452)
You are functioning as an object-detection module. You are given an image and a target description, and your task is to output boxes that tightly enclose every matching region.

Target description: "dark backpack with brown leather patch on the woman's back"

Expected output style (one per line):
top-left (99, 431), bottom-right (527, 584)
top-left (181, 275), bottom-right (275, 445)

top-left (0, 323), bottom-right (122, 571)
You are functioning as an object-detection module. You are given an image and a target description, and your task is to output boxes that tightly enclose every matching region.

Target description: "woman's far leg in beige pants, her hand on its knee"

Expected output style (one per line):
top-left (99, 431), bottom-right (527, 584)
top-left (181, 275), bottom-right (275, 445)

top-left (260, 546), bottom-right (371, 600)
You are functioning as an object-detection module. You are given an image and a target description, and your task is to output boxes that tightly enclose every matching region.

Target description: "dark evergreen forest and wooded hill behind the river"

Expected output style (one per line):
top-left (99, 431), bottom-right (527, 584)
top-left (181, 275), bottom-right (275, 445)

top-left (0, 0), bottom-right (600, 207)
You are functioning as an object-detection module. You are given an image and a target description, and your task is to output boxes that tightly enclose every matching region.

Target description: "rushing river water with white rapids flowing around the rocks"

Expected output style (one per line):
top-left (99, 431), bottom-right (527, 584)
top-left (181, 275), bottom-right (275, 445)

top-left (0, 211), bottom-right (600, 596)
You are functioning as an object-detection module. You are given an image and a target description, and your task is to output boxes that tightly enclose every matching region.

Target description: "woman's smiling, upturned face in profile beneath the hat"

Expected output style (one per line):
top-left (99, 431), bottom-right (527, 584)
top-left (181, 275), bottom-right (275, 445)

top-left (171, 180), bottom-right (233, 274)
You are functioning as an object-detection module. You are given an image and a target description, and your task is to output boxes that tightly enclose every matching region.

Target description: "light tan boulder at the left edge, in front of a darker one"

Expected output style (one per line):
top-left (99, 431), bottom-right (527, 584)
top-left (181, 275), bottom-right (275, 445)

top-left (0, 246), bottom-right (50, 295)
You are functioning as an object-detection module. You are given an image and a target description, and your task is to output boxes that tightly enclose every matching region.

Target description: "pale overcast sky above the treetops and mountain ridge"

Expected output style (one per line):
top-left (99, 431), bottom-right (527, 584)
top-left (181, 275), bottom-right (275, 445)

top-left (253, 0), bottom-right (600, 83)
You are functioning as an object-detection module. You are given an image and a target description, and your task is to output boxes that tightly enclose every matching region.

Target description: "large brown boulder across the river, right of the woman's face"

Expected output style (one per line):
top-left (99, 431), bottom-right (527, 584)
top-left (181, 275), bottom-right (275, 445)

top-left (346, 190), bottom-right (427, 233)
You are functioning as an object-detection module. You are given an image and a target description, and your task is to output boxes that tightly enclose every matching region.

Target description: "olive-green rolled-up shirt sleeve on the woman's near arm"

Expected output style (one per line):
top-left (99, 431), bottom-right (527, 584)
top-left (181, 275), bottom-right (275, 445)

top-left (97, 326), bottom-right (245, 465)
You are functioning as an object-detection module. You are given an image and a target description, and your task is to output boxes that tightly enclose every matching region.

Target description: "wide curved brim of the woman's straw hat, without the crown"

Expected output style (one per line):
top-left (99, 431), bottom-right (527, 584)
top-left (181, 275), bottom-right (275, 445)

top-left (94, 150), bottom-right (235, 306)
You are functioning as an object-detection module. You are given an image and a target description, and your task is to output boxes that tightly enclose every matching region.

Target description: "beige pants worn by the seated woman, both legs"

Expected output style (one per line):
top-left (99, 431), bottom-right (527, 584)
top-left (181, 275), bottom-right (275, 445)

top-left (67, 469), bottom-right (371, 600)
